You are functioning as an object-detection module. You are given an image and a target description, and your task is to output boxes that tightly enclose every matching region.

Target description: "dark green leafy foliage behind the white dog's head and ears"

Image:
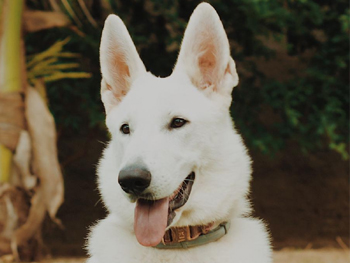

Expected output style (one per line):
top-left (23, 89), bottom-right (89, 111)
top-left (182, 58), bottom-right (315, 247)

top-left (26, 0), bottom-right (350, 159)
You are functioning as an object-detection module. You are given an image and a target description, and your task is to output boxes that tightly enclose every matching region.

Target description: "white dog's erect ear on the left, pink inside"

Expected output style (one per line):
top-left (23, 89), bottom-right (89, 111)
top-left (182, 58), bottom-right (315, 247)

top-left (100, 15), bottom-right (146, 113)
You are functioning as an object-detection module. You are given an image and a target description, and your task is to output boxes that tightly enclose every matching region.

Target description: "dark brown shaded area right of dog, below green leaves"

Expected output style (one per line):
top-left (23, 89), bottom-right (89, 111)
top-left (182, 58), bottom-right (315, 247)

top-left (251, 147), bottom-right (349, 249)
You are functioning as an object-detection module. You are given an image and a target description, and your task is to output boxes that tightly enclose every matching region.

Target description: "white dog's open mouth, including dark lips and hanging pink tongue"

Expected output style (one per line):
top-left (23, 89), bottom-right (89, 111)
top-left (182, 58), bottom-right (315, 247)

top-left (134, 172), bottom-right (195, 246)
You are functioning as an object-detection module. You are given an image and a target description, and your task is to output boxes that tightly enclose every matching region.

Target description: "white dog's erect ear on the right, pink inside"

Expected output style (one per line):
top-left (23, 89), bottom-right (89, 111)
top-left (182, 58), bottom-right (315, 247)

top-left (174, 3), bottom-right (238, 101)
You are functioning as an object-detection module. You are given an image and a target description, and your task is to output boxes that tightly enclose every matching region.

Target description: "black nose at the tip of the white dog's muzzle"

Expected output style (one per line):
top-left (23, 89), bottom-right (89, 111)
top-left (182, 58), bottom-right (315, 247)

top-left (118, 166), bottom-right (151, 195)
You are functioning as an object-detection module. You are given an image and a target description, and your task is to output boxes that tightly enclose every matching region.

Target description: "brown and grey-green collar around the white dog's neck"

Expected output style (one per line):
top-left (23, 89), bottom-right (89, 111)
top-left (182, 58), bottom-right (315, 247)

top-left (155, 222), bottom-right (230, 249)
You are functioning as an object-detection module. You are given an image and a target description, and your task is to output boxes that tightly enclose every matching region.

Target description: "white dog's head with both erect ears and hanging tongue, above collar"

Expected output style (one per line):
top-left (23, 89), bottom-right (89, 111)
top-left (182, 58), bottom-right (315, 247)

top-left (99, 3), bottom-right (250, 249)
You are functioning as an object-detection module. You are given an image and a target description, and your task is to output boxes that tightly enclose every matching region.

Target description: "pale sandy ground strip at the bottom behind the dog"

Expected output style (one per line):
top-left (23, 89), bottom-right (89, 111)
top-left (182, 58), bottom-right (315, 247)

top-left (40, 249), bottom-right (350, 263)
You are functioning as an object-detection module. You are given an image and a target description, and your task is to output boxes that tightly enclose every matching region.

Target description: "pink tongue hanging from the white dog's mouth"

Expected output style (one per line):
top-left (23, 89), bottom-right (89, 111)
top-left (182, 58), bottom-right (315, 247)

top-left (134, 197), bottom-right (169, 247)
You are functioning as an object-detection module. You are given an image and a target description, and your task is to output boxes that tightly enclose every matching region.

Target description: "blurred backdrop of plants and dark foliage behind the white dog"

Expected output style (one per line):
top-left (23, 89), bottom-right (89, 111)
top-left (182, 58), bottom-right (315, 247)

top-left (0, 0), bottom-right (350, 260)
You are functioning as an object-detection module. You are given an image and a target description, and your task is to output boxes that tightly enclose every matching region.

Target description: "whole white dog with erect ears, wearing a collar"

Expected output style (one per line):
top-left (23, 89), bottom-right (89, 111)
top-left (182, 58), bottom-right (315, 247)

top-left (88, 3), bottom-right (271, 263)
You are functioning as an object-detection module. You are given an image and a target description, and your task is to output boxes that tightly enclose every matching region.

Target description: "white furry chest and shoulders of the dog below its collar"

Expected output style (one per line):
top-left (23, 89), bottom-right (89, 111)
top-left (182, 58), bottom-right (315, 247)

top-left (89, 218), bottom-right (271, 263)
